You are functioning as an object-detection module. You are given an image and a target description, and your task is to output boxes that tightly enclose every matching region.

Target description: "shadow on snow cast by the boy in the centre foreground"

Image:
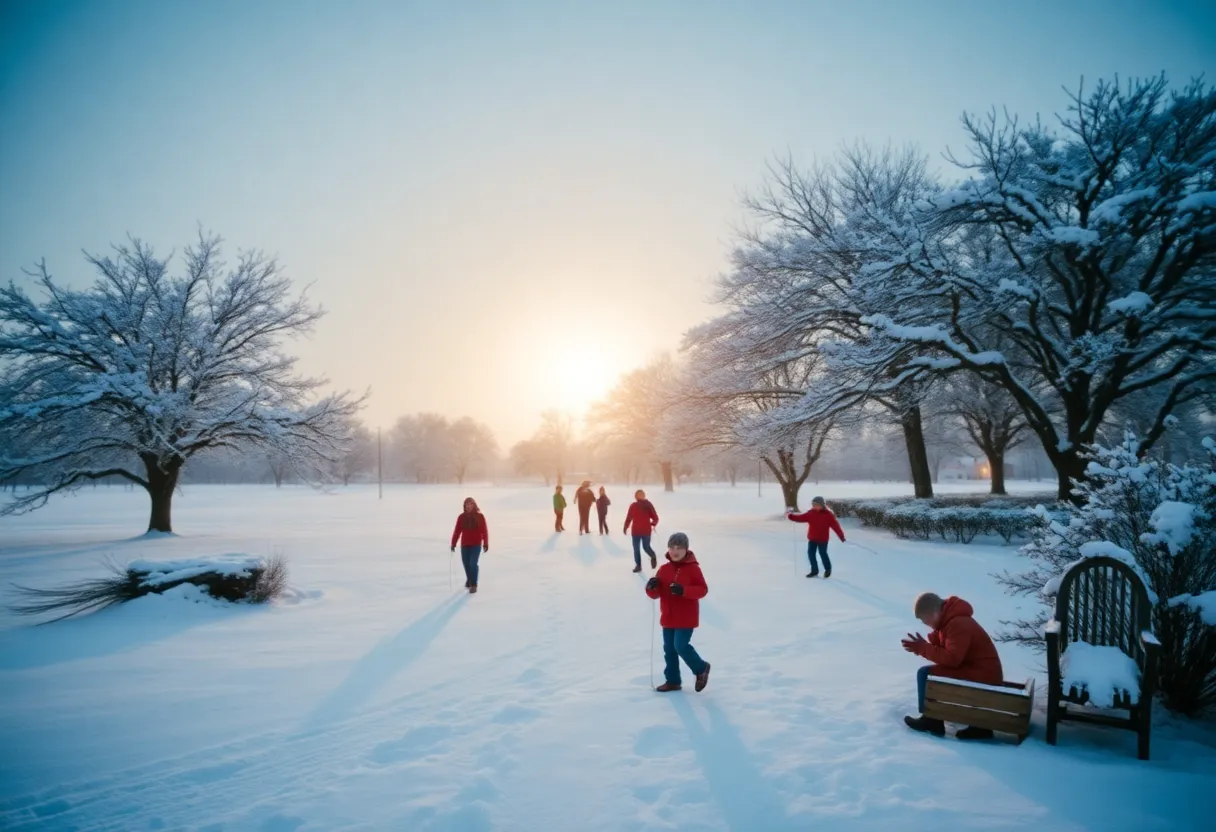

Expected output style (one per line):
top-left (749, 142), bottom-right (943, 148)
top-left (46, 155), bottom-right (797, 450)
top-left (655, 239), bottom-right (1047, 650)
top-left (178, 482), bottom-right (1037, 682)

top-left (668, 693), bottom-right (796, 832)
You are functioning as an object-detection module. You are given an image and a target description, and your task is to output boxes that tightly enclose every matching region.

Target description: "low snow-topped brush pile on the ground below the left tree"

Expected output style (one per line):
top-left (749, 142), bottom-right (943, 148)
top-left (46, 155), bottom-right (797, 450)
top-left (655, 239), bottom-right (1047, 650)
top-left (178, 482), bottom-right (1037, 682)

top-left (12, 555), bottom-right (287, 620)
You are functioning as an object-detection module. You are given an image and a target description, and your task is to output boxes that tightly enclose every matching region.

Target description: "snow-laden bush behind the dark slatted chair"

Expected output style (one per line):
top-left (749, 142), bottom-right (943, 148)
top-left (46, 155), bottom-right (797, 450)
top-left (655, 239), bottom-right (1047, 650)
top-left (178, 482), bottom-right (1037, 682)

top-left (998, 433), bottom-right (1216, 714)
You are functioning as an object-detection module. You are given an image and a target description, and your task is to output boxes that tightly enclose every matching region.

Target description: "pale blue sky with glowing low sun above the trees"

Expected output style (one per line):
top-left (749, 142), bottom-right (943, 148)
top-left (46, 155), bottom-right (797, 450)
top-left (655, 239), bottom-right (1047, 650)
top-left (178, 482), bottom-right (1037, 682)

top-left (0, 0), bottom-right (1216, 444)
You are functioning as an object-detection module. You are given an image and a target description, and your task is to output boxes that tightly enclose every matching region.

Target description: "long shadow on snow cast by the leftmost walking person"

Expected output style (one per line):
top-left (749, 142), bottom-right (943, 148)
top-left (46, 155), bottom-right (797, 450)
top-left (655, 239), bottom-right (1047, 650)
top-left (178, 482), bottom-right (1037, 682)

top-left (299, 592), bottom-right (468, 733)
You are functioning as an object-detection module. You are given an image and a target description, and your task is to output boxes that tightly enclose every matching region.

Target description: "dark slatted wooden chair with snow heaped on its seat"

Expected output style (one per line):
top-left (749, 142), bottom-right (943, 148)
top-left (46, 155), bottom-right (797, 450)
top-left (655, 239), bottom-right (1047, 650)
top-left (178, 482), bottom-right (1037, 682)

top-left (1043, 557), bottom-right (1161, 760)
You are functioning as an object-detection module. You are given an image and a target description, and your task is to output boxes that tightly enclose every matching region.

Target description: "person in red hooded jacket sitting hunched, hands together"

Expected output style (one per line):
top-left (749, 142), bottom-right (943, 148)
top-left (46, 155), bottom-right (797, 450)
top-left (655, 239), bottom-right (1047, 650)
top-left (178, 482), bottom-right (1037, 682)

top-left (902, 592), bottom-right (1004, 740)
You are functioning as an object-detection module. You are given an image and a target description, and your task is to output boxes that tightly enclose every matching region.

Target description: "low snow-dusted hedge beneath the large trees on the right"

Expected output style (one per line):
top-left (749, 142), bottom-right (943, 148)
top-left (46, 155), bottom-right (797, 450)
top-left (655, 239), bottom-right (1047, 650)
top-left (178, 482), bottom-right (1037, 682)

top-left (832, 495), bottom-right (1043, 543)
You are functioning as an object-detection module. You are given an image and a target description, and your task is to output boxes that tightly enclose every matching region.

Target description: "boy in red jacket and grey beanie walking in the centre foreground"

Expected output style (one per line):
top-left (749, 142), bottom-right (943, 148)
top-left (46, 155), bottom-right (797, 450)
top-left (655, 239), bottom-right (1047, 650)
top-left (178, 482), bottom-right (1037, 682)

top-left (646, 532), bottom-right (709, 693)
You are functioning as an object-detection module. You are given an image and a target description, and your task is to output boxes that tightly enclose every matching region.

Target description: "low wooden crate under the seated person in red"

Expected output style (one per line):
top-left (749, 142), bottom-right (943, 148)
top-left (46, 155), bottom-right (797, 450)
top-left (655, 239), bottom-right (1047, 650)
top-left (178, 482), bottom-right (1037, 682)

top-left (924, 676), bottom-right (1035, 746)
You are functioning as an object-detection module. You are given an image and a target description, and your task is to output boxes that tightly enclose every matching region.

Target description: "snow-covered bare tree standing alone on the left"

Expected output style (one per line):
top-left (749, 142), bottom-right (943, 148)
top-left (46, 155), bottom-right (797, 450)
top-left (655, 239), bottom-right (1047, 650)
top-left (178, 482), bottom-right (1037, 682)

top-left (0, 235), bottom-right (361, 532)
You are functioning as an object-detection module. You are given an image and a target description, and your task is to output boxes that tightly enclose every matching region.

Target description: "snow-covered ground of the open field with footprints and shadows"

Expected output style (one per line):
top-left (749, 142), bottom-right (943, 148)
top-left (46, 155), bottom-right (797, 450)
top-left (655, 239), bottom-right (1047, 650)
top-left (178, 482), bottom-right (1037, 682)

top-left (0, 483), bottom-right (1216, 832)
